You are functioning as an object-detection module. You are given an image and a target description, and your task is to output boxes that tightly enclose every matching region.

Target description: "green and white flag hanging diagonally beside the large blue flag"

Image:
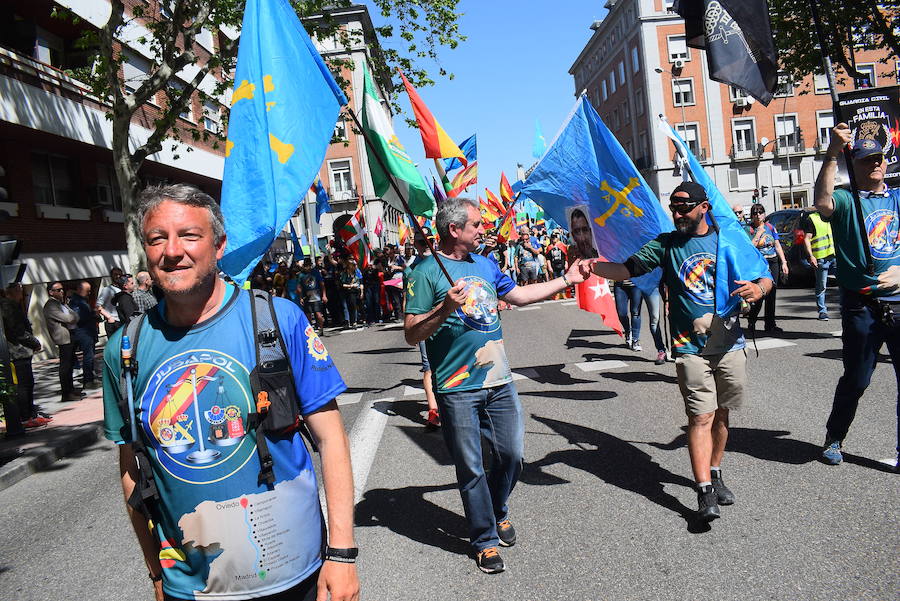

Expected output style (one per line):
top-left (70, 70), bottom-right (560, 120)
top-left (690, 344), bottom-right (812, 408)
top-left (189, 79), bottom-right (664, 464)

top-left (362, 65), bottom-right (434, 217)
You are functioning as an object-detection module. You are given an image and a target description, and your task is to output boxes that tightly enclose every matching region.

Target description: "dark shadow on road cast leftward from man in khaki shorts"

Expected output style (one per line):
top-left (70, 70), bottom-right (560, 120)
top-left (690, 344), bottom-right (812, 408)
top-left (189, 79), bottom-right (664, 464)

top-left (521, 414), bottom-right (710, 533)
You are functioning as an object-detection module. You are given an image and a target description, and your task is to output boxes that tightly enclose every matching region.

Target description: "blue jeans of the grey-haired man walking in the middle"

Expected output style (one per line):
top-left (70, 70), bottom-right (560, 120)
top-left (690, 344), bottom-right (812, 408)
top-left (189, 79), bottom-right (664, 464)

top-left (437, 383), bottom-right (525, 552)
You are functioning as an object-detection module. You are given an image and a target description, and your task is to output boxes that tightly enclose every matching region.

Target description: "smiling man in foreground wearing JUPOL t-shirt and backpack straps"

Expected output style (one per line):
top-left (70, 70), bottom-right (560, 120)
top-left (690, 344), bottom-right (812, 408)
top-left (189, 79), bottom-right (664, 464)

top-left (103, 185), bottom-right (359, 601)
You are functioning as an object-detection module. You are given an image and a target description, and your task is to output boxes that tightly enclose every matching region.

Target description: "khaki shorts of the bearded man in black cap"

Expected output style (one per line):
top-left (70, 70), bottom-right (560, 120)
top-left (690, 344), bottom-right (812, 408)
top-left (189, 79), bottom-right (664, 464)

top-left (675, 349), bottom-right (747, 416)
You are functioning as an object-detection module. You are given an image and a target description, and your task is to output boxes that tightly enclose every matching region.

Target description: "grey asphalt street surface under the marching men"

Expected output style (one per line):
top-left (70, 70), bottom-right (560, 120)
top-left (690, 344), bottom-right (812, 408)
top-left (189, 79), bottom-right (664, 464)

top-left (0, 290), bottom-right (900, 601)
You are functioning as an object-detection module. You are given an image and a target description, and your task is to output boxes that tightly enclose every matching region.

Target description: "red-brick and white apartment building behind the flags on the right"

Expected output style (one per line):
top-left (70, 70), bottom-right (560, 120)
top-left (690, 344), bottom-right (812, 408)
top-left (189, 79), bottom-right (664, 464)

top-left (569, 0), bottom-right (898, 212)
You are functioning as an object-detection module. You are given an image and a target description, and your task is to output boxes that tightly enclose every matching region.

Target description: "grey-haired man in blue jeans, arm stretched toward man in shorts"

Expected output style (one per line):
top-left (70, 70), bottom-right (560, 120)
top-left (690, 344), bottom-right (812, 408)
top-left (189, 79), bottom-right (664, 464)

top-left (404, 197), bottom-right (588, 574)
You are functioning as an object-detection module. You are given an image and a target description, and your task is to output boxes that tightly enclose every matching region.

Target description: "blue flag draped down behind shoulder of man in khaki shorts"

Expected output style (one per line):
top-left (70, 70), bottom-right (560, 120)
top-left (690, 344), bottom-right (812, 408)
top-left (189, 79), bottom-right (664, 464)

top-left (659, 120), bottom-right (771, 317)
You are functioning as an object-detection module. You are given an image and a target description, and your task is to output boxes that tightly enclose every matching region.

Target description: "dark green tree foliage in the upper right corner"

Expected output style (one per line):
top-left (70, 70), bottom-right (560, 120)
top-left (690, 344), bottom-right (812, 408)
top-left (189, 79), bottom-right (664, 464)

top-left (769, 0), bottom-right (900, 83)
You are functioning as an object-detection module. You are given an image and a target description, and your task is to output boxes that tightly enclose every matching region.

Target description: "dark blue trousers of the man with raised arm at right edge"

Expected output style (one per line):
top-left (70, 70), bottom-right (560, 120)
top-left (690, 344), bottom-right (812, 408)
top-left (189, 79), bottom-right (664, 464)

top-left (826, 289), bottom-right (900, 452)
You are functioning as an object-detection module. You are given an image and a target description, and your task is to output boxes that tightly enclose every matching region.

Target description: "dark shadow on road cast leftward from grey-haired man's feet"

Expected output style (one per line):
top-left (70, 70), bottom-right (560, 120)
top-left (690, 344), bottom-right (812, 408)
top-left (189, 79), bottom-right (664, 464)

top-left (356, 483), bottom-right (470, 555)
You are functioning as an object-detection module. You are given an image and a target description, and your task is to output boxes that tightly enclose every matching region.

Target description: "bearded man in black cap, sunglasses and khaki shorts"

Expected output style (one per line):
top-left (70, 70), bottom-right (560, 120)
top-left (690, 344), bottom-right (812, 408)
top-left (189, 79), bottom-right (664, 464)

top-left (592, 182), bottom-right (772, 522)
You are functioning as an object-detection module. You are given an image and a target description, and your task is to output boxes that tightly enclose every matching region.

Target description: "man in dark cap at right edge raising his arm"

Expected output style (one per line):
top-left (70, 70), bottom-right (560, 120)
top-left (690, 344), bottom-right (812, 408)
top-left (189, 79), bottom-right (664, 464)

top-left (815, 123), bottom-right (900, 465)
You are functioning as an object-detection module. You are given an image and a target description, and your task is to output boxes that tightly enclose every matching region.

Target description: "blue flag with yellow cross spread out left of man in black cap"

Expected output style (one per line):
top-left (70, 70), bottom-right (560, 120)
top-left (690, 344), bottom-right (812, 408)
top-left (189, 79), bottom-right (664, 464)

top-left (522, 96), bottom-right (672, 291)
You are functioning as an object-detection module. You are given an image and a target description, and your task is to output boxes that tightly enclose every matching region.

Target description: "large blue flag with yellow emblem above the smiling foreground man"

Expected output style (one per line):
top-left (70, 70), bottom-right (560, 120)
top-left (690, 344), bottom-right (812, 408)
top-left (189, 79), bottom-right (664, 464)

top-left (219, 0), bottom-right (347, 283)
